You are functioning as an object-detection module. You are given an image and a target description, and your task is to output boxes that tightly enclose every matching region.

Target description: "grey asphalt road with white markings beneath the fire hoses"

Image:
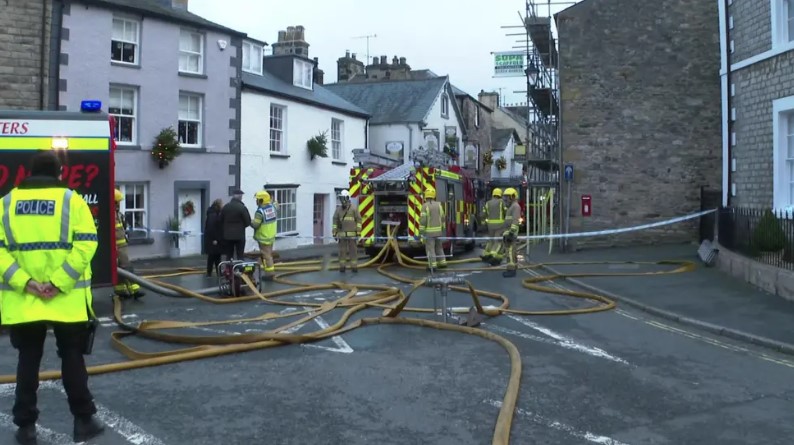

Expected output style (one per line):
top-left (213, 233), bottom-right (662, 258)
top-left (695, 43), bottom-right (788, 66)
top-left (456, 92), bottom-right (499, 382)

top-left (0, 246), bottom-right (794, 445)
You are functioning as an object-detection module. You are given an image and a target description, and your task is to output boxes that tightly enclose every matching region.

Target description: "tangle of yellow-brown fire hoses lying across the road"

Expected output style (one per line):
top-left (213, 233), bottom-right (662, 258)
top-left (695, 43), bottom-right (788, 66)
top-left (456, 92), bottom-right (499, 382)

top-left (0, 229), bottom-right (695, 445)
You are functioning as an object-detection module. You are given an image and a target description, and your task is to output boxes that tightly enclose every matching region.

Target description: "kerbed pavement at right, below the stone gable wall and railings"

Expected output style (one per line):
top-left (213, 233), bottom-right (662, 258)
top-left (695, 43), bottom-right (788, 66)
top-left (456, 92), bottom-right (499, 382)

top-left (530, 244), bottom-right (794, 354)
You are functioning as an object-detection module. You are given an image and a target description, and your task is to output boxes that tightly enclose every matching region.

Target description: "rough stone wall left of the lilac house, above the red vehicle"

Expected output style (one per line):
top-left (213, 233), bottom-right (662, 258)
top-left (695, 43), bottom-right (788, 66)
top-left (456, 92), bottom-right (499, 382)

top-left (0, 0), bottom-right (52, 110)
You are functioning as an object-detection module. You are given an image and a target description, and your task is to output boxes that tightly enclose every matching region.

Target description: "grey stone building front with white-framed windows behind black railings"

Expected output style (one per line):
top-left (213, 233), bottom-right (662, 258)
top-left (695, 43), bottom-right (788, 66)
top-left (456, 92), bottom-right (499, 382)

top-left (718, 0), bottom-right (794, 209)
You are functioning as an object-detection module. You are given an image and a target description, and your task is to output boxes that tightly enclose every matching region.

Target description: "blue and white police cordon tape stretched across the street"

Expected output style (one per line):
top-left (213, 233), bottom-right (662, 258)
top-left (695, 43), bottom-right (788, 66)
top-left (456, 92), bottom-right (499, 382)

top-left (128, 209), bottom-right (717, 241)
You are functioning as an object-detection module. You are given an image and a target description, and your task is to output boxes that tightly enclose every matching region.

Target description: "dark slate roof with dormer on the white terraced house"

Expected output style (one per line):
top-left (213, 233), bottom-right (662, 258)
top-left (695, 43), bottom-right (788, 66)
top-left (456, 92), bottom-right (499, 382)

top-left (243, 71), bottom-right (370, 118)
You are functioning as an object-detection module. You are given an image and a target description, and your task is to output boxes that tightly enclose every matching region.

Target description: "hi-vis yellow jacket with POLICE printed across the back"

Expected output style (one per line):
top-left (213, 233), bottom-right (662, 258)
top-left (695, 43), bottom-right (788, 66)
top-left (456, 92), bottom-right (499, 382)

top-left (0, 177), bottom-right (97, 325)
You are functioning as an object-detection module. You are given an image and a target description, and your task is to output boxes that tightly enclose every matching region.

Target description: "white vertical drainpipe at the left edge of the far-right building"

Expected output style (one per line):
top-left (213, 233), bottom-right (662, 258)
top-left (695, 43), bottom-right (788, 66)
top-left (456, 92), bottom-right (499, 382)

top-left (717, 0), bottom-right (731, 206)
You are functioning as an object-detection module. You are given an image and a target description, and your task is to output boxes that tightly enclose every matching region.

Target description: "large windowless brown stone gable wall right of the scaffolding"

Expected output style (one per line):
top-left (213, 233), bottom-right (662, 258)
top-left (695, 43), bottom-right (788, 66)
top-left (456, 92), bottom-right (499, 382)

top-left (556, 0), bottom-right (720, 248)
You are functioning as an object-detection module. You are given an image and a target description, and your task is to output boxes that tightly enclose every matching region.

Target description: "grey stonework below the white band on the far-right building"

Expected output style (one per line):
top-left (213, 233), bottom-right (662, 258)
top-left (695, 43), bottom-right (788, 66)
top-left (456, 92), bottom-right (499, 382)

top-left (731, 42), bottom-right (794, 208)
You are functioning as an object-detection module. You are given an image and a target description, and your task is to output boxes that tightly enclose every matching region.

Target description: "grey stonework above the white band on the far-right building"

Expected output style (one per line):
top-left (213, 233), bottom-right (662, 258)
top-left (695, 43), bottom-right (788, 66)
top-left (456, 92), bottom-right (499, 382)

top-left (728, 0), bottom-right (777, 63)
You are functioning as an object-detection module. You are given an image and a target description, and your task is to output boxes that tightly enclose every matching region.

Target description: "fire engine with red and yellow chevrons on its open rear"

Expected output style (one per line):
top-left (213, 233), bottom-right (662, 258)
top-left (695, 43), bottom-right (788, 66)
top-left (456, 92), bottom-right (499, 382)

top-left (349, 152), bottom-right (477, 256)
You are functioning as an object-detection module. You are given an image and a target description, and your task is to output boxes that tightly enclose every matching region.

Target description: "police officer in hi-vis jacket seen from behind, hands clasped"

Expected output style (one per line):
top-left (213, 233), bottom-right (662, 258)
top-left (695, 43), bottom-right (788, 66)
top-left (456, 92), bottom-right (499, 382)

top-left (0, 152), bottom-right (104, 445)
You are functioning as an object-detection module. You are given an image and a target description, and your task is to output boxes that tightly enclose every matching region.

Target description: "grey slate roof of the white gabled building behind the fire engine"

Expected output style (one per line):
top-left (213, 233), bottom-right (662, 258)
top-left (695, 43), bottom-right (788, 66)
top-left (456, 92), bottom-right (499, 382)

top-left (325, 76), bottom-right (447, 125)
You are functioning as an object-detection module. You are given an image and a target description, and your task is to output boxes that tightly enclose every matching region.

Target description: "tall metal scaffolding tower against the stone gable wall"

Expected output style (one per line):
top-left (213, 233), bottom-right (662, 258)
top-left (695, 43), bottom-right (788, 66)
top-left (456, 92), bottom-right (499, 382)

top-left (503, 0), bottom-right (581, 249)
